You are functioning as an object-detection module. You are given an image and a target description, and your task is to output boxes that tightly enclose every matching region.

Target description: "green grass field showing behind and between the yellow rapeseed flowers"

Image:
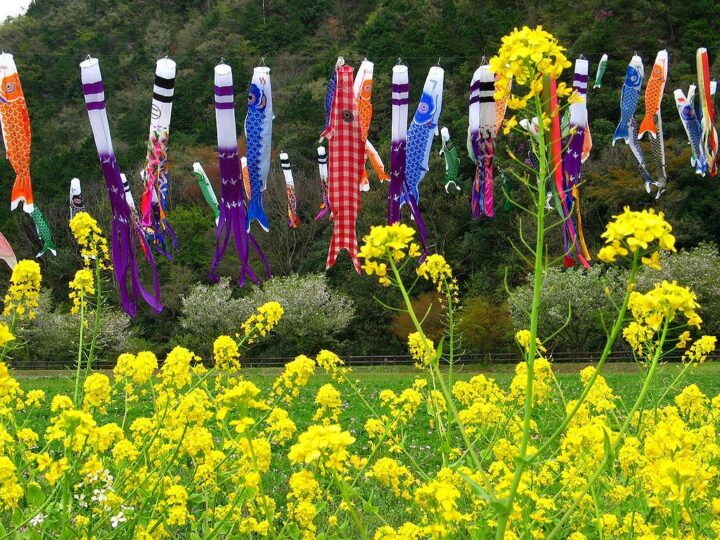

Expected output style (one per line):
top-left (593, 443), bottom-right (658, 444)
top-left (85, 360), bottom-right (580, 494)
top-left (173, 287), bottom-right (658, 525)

top-left (7, 364), bottom-right (720, 530)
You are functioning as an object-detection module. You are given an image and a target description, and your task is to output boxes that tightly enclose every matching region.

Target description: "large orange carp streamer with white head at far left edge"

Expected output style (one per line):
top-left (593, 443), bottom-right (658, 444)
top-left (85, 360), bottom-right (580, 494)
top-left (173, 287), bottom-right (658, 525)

top-left (0, 52), bottom-right (33, 214)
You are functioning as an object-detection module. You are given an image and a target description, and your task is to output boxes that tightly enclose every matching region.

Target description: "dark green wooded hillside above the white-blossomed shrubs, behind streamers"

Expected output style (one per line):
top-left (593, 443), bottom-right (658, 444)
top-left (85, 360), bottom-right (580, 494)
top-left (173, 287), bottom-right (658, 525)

top-left (0, 0), bottom-right (720, 353)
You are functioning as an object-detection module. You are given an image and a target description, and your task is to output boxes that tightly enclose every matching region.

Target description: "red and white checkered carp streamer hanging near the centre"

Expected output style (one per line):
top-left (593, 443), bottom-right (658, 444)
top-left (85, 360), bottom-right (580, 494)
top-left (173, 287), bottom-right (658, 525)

top-left (322, 65), bottom-right (365, 273)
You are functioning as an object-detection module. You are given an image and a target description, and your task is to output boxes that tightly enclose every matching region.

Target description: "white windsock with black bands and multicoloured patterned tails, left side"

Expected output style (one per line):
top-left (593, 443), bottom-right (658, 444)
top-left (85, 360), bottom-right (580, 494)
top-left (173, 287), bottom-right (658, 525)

top-left (140, 58), bottom-right (177, 259)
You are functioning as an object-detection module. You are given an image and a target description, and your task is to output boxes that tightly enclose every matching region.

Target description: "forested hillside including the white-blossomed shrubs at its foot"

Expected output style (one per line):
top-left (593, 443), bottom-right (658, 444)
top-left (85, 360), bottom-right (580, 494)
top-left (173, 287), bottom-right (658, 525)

top-left (0, 0), bottom-right (720, 362)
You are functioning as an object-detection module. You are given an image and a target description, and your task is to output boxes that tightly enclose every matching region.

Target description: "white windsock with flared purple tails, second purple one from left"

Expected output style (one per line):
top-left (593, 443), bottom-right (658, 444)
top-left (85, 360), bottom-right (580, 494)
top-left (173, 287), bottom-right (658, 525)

top-left (209, 64), bottom-right (272, 287)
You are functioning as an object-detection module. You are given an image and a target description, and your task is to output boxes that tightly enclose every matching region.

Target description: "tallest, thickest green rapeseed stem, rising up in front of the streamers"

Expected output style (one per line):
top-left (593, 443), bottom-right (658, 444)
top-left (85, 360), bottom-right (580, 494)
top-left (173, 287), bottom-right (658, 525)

top-left (495, 95), bottom-right (548, 540)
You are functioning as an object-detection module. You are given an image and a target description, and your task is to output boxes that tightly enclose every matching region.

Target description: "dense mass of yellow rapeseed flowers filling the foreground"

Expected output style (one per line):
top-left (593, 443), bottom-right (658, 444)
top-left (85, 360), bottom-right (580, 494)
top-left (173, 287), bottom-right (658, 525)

top-left (0, 308), bottom-right (720, 539)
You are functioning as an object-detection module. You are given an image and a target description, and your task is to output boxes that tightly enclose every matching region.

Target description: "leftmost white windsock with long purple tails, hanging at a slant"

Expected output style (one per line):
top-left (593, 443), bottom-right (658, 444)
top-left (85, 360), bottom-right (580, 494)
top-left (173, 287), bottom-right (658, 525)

top-left (80, 58), bottom-right (162, 317)
